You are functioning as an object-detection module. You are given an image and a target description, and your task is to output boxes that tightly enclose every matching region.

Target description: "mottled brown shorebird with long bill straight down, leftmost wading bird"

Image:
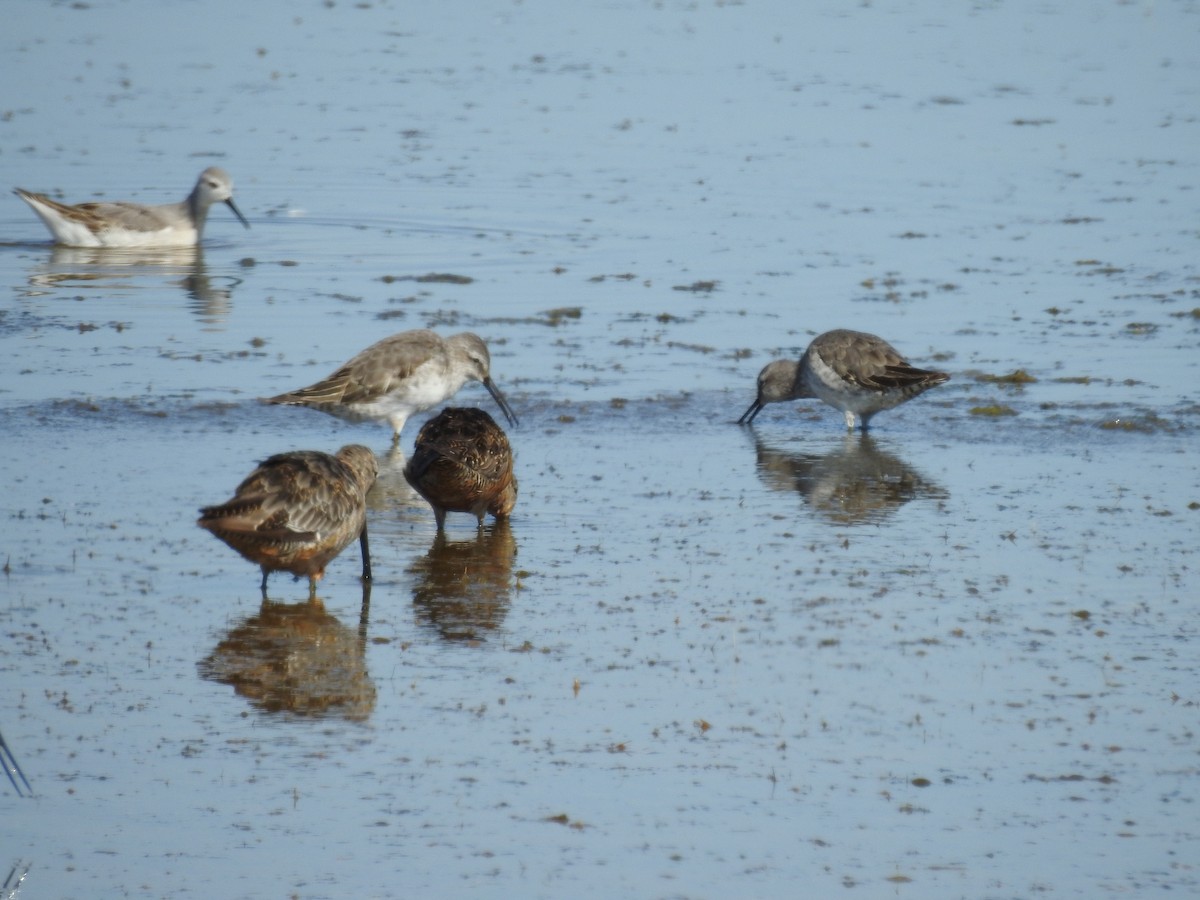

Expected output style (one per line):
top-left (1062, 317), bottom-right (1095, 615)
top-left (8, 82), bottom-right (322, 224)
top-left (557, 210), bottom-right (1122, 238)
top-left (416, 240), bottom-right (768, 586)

top-left (197, 444), bottom-right (379, 598)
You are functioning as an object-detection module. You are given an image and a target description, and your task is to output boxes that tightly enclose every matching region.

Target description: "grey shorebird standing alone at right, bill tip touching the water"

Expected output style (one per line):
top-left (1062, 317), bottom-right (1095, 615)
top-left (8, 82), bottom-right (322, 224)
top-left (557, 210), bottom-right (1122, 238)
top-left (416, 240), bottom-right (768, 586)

top-left (738, 329), bottom-right (950, 431)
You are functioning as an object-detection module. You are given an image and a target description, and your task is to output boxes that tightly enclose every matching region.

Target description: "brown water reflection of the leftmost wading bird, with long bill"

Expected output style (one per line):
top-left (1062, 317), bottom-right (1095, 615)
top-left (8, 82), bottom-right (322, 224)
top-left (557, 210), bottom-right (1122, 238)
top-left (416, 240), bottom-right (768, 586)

top-left (198, 584), bottom-right (376, 721)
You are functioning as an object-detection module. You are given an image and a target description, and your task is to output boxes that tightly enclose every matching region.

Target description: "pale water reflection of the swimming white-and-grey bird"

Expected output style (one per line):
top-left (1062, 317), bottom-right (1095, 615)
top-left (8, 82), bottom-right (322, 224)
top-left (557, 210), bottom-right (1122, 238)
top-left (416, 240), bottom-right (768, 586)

top-left (29, 247), bottom-right (241, 325)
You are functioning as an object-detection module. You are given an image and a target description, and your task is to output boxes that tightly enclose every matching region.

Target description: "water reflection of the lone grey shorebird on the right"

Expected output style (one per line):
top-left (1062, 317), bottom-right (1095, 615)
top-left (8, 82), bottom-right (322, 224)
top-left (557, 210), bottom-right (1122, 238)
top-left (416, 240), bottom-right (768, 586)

top-left (755, 434), bottom-right (949, 524)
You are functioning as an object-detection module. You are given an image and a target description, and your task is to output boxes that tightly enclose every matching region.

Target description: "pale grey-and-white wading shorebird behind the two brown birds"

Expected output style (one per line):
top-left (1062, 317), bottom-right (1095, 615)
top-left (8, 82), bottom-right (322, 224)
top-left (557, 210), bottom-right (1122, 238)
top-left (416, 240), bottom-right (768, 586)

top-left (266, 329), bottom-right (517, 444)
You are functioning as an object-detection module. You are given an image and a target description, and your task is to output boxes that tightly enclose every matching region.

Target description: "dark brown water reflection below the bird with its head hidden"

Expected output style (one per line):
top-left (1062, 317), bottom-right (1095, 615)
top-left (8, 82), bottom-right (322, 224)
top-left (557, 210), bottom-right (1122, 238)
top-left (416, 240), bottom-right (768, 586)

top-left (408, 520), bottom-right (517, 641)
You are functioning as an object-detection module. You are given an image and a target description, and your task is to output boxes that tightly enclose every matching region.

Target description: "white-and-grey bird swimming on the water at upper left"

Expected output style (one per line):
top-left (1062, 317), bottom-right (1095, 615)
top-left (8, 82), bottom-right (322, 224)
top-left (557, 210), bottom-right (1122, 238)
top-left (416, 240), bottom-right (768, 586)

top-left (13, 166), bottom-right (250, 247)
